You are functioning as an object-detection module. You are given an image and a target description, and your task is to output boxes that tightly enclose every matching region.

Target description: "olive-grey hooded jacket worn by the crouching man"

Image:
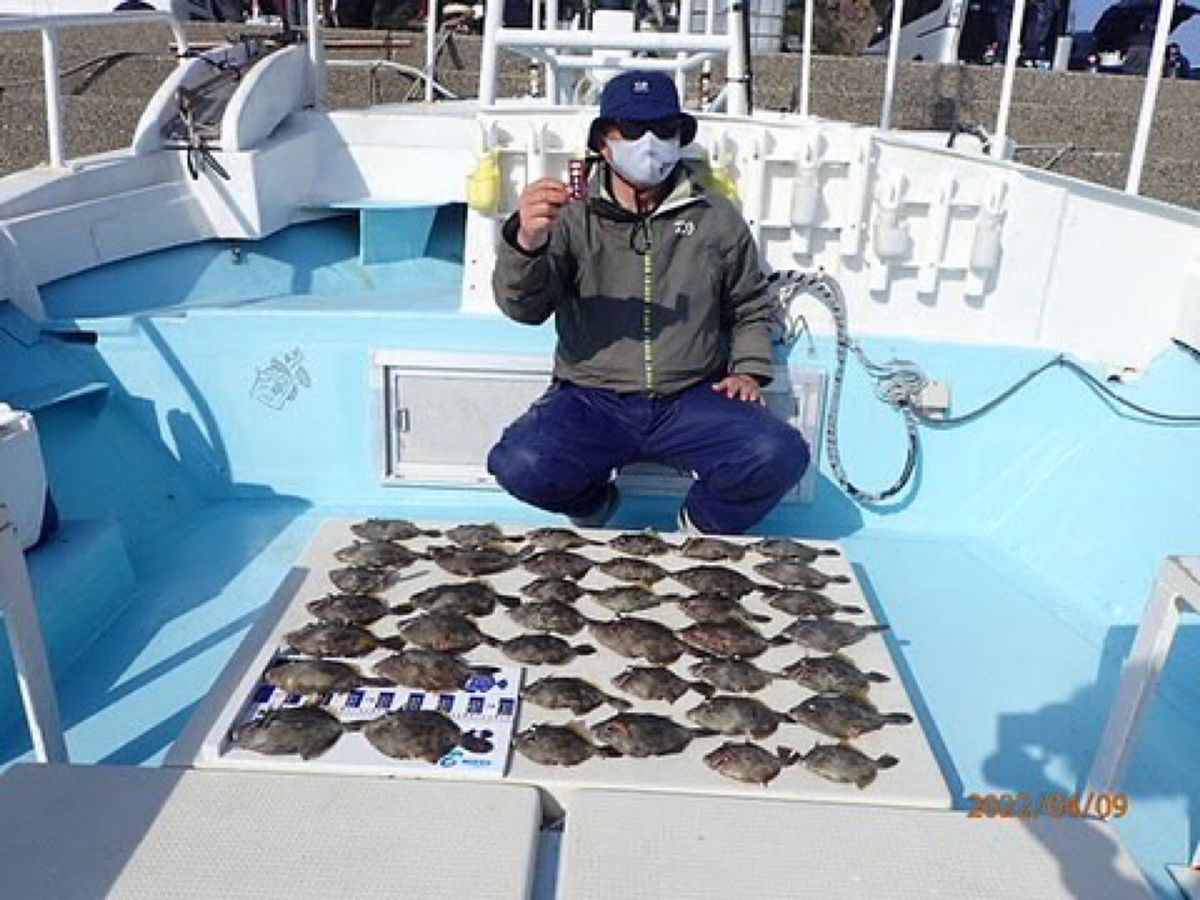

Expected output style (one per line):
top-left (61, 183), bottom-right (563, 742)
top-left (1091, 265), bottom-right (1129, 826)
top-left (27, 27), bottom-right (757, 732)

top-left (492, 163), bottom-right (772, 395)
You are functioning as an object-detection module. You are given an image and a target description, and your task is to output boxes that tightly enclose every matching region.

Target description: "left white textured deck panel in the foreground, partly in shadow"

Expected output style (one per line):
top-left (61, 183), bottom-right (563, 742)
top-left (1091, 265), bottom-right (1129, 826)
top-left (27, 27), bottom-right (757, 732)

top-left (0, 766), bottom-right (540, 900)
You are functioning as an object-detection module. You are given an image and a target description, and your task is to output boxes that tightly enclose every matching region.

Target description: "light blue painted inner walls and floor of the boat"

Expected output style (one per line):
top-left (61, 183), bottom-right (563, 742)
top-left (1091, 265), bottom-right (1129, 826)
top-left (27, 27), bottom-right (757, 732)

top-left (0, 220), bottom-right (1200, 896)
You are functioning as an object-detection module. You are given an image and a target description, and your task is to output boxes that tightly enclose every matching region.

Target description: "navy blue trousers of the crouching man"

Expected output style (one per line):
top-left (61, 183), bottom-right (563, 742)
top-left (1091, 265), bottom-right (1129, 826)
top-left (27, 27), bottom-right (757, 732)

top-left (487, 380), bottom-right (809, 534)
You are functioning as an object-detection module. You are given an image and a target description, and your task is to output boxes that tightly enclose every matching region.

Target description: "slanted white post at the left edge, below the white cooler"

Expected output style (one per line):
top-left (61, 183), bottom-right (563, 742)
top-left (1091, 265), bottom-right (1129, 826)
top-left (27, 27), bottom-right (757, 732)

top-left (0, 518), bottom-right (70, 762)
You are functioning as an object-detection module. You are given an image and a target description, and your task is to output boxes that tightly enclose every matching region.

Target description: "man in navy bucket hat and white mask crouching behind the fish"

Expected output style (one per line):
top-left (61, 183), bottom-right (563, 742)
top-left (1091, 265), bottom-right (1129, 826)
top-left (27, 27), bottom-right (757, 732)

top-left (487, 72), bottom-right (809, 534)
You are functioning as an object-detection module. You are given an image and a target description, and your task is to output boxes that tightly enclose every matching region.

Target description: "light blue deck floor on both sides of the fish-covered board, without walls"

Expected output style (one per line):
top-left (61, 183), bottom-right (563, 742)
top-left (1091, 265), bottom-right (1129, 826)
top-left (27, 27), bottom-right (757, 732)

top-left (0, 499), bottom-right (1200, 896)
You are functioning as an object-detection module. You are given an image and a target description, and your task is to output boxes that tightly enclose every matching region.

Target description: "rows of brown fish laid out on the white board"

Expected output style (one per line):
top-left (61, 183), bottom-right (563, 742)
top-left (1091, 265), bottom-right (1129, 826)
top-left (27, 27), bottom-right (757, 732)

top-left (233, 520), bottom-right (911, 787)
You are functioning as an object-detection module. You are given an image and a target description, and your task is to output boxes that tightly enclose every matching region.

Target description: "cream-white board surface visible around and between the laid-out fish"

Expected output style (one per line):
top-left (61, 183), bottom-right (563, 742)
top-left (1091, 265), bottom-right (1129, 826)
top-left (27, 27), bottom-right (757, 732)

top-left (189, 520), bottom-right (952, 809)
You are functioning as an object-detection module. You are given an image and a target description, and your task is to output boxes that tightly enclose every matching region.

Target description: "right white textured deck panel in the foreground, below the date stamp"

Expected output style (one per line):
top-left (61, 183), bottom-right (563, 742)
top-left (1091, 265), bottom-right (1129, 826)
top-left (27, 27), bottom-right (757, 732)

top-left (558, 791), bottom-right (1153, 900)
